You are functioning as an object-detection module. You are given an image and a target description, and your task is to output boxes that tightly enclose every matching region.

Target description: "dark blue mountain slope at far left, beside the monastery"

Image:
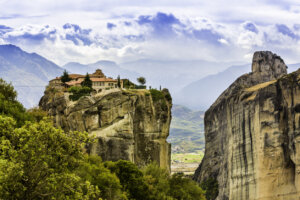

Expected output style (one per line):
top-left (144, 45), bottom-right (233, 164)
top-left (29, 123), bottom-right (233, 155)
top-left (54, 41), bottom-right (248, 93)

top-left (0, 45), bottom-right (63, 108)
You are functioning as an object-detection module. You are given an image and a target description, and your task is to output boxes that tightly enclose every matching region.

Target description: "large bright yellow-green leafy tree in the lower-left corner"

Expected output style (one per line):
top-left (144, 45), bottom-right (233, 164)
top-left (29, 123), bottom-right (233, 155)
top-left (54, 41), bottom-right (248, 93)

top-left (0, 115), bottom-right (100, 199)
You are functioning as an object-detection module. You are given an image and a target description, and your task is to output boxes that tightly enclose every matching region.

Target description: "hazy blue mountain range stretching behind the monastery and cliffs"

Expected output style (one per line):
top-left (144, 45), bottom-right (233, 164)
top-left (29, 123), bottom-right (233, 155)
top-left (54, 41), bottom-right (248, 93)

top-left (0, 45), bottom-right (299, 110)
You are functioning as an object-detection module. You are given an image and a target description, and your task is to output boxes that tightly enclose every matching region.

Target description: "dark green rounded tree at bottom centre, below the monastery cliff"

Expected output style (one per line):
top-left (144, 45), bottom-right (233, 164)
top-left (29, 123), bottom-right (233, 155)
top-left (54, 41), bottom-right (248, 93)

top-left (105, 160), bottom-right (150, 200)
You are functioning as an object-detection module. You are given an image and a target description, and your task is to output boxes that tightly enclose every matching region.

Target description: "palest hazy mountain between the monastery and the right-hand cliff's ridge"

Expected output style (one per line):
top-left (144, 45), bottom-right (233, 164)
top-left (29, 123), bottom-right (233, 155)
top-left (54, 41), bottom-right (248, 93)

top-left (120, 59), bottom-right (234, 94)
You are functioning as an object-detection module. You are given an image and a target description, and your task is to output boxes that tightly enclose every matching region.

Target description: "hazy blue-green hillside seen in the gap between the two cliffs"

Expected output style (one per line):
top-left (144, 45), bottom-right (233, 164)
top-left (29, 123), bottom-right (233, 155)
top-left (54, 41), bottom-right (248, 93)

top-left (168, 105), bottom-right (205, 153)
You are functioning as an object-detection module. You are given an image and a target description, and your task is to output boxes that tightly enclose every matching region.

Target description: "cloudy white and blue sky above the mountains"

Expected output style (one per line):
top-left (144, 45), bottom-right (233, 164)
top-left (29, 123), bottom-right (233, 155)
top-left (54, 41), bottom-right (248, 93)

top-left (0, 0), bottom-right (300, 65)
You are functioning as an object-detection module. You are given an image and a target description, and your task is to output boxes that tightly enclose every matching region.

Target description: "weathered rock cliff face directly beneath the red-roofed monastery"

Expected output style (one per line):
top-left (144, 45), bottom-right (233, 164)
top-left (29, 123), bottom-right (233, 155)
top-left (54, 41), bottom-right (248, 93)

top-left (40, 89), bottom-right (172, 170)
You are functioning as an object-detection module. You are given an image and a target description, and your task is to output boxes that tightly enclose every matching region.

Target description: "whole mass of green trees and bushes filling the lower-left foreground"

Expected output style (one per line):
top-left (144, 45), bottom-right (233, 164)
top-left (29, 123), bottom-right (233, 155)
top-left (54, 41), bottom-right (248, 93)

top-left (0, 81), bottom-right (205, 200)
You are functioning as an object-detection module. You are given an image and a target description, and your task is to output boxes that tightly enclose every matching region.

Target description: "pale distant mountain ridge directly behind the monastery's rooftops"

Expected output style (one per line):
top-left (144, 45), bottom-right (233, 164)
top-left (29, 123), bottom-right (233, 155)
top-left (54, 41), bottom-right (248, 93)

top-left (63, 60), bottom-right (141, 81)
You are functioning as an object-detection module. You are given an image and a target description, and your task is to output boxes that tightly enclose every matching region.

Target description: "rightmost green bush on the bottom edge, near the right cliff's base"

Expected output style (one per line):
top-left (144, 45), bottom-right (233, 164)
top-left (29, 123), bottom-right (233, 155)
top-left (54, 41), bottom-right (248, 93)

top-left (170, 174), bottom-right (205, 200)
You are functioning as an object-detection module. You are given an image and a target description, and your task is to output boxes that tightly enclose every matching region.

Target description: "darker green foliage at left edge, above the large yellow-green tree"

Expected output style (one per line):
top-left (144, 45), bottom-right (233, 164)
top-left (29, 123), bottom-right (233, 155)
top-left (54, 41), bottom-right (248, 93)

top-left (0, 78), bottom-right (32, 127)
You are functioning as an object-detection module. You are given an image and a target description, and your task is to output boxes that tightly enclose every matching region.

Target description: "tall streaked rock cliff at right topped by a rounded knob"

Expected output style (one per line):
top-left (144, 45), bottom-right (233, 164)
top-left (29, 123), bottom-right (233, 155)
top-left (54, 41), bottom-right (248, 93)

top-left (194, 52), bottom-right (300, 200)
